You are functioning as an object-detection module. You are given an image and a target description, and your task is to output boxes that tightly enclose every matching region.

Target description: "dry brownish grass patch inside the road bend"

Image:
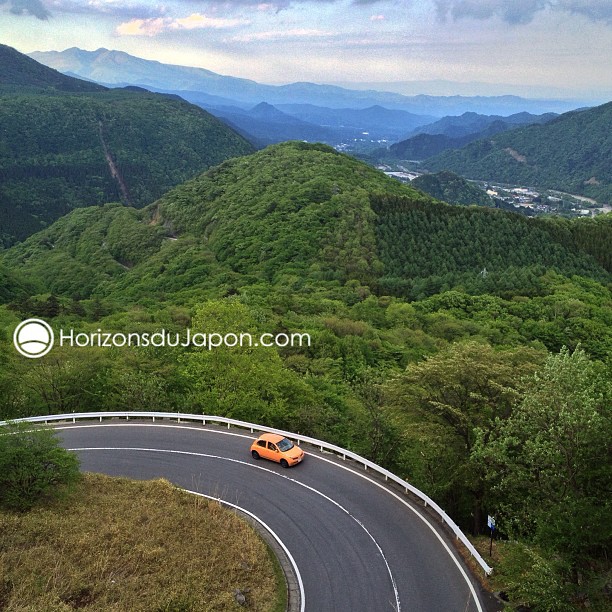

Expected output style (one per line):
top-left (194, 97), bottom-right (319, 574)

top-left (0, 474), bottom-right (285, 612)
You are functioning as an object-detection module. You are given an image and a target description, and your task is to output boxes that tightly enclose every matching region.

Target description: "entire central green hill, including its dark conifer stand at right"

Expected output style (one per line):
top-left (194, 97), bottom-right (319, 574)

top-left (4, 142), bottom-right (612, 302)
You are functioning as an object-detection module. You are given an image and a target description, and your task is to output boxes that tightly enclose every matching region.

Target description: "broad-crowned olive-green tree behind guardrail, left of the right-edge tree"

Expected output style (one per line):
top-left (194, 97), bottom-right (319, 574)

top-left (389, 341), bottom-right (543, 533)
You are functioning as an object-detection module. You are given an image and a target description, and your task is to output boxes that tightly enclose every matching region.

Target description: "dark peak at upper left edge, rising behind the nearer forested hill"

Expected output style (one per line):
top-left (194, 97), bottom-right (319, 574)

top-left (0, 45), bottom-right (106, 92)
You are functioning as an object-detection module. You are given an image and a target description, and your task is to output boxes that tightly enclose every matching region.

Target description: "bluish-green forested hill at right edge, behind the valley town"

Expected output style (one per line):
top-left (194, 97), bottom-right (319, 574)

top-left (426, 102), bottom-right (612, 203)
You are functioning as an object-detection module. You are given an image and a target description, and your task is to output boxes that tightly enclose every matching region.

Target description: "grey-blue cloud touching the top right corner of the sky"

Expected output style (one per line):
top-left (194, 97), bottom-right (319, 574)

top-left (434, 0), bottom-right (612, 25)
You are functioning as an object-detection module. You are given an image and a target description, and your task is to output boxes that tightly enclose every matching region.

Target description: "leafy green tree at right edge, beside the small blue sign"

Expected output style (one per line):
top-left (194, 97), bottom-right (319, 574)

top-left (473, 348), bottom-right (612, 563)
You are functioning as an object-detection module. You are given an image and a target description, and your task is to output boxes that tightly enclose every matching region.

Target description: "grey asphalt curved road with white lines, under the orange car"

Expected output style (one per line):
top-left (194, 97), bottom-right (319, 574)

top-left (56, 422), bottom-right (483, 612)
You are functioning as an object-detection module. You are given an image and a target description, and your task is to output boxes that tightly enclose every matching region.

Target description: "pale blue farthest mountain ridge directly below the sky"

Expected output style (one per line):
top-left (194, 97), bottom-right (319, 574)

top-left (30, 47), bottom-right (572, 116)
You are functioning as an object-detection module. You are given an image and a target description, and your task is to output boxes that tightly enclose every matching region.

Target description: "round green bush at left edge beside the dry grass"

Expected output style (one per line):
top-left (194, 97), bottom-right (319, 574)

top-left (0, 423), bottom-right (79, 512)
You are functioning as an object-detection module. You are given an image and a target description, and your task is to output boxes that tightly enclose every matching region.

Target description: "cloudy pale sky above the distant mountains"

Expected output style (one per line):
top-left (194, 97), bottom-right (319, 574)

top-left (0, 0), bottom-right (612, 101)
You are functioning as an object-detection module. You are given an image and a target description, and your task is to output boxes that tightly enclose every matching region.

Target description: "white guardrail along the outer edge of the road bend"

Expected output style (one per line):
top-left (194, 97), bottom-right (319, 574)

top-left (0, 412), bottom-right (493, 574)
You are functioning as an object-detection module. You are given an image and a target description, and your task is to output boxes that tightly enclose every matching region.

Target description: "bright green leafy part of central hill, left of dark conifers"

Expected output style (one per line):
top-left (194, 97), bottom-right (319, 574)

top-left (5, 142), bottom-right (422, 298)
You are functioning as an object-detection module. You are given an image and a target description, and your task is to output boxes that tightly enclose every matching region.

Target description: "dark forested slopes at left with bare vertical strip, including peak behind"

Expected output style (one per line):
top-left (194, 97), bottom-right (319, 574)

top-left (0, 47), bottom-right (253, 247)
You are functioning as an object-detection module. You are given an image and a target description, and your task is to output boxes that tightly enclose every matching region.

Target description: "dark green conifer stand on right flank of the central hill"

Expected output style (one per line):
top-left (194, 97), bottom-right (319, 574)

top-left (372, 195), bottom-right (612, 299)
